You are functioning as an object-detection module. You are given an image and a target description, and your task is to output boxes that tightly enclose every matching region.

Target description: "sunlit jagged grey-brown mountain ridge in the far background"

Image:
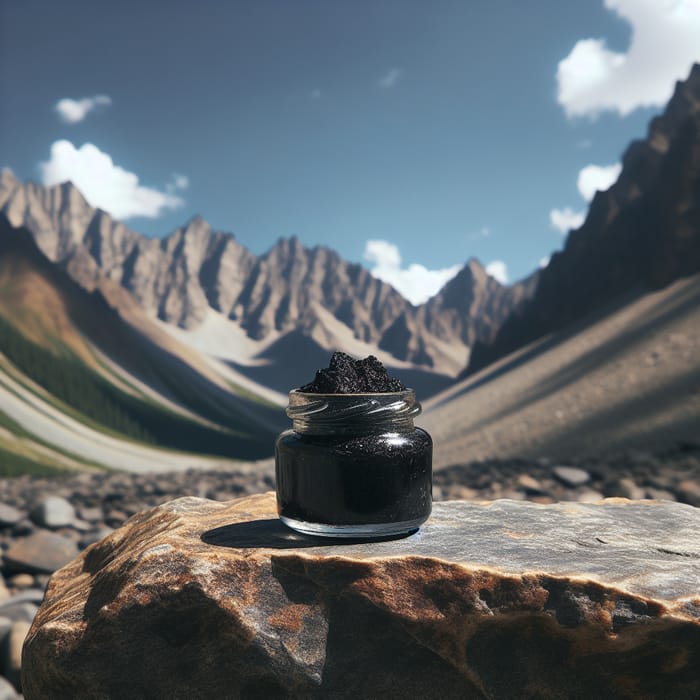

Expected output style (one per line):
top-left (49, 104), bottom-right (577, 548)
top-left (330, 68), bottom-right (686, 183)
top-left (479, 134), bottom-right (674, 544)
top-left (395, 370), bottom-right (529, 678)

top-left (0, 170), bottom-right (536, 375)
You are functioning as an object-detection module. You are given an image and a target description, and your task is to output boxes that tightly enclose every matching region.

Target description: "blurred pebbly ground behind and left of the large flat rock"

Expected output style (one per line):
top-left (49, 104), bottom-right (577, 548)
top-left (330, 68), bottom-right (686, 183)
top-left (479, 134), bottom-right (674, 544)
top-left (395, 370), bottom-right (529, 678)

top-left (0, 444), bottom-right (700, 700)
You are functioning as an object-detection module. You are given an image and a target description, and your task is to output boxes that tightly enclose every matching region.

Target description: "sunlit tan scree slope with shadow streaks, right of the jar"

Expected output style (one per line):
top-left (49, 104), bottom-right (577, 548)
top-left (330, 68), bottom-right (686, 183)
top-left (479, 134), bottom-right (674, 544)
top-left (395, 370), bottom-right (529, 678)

top-left (421, 274), bottom-right (700, 468)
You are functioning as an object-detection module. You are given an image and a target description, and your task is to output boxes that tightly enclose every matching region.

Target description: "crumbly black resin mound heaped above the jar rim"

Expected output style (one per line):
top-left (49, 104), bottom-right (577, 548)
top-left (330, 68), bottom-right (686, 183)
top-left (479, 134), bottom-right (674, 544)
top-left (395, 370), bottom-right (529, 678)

top-left (299, 352), bottom-right (406, 394)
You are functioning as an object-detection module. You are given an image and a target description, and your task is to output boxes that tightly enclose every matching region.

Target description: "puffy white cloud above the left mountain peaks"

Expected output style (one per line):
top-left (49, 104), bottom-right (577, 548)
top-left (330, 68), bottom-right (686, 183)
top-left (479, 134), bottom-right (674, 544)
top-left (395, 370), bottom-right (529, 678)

top-left (39, 140), bottom-right (189, 219)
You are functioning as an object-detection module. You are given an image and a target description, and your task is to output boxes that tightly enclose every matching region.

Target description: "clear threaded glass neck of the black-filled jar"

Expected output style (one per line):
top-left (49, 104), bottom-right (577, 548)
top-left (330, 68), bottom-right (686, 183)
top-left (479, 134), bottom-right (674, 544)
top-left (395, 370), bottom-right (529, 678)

top-left (287, 389), bottom-right (421, 435)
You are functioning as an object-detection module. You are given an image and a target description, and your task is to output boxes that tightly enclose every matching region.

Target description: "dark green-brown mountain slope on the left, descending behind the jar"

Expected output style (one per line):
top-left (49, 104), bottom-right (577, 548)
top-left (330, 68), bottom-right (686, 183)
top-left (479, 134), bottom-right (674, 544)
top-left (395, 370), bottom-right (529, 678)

top-left (0, 216), bottom-right (283, 468)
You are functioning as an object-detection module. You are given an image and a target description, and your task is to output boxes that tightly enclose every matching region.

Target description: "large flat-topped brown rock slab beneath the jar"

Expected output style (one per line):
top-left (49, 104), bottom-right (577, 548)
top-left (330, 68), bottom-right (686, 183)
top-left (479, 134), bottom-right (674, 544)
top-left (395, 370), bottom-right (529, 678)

top-left (22, 494), bottom-right (700, 700)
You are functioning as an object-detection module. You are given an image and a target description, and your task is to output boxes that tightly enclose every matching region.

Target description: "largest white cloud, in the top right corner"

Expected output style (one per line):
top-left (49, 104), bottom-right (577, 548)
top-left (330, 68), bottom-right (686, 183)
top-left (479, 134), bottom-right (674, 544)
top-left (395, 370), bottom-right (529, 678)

top-left (557, 0), bottom-right (700, 117)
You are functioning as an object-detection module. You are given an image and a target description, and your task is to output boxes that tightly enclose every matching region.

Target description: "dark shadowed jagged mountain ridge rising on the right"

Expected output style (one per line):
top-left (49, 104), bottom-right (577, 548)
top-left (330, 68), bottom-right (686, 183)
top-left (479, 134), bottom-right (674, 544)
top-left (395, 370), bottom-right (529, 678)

top-left (467, 64), bottom-right (700, 374)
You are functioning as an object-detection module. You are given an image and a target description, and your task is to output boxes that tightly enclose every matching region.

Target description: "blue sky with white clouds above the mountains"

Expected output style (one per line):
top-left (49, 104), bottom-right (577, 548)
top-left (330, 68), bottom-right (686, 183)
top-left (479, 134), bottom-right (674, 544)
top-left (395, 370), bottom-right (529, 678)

top-left (0, 0), bottom-right (700, 300)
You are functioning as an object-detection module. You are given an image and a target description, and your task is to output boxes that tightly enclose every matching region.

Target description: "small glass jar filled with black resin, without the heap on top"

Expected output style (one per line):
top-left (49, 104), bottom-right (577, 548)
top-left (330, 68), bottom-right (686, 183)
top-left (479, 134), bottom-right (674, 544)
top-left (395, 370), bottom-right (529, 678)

top-left (275, 389), bottom-right (433, 537)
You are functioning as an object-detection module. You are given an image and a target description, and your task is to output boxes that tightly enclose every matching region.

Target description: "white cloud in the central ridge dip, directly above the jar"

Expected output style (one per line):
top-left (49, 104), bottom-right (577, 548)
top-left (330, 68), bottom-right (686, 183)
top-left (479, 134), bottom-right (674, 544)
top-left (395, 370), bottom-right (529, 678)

top-left (364, 240), bottom-right (461, 306)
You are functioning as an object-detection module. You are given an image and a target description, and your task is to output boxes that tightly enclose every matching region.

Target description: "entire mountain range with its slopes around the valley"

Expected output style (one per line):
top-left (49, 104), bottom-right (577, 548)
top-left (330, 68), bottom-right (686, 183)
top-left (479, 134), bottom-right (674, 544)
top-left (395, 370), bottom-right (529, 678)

top-left (0, 66), bottom-right (700, 471)
